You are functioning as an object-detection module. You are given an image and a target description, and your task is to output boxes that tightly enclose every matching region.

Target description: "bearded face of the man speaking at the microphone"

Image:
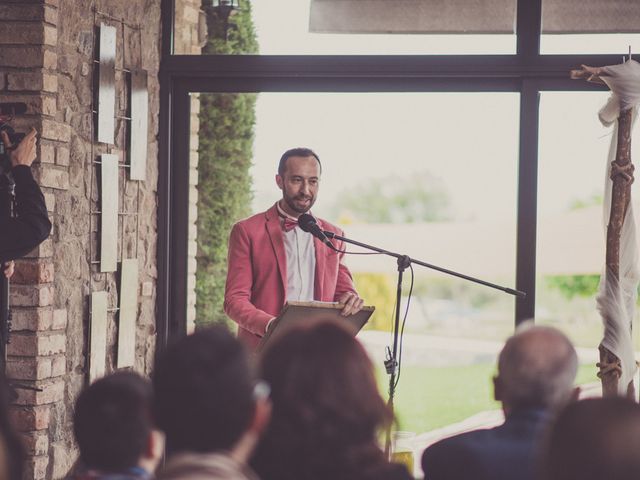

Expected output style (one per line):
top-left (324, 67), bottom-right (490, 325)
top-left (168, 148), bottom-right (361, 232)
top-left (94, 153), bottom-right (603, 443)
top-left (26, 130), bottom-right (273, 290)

top-left (276, 156), bottom-right (320, 217)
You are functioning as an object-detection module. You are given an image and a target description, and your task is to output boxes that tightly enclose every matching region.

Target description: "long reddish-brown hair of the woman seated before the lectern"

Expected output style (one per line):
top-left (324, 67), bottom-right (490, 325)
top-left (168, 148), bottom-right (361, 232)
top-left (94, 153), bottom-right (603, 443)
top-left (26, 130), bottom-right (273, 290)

top-left (254, 321), bottom-right (393, 480)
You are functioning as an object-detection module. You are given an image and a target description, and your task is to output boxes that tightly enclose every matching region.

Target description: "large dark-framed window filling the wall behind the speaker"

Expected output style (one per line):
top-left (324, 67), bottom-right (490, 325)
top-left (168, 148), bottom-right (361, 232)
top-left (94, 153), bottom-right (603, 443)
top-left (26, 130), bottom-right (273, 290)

top-left (158, 0), bottom-right (640, 472)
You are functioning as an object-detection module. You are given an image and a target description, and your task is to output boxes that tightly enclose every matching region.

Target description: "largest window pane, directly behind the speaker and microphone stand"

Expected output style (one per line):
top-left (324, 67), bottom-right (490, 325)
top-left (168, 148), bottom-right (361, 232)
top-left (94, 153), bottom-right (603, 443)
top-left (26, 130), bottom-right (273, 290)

top-left (192, 93), bottom-right (519, 474)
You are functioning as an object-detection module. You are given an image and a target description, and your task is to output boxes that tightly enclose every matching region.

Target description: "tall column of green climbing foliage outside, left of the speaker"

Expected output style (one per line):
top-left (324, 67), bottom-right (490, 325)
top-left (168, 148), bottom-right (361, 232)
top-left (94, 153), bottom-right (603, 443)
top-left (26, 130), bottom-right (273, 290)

top-left (196, 1), bottom-right (258, 326)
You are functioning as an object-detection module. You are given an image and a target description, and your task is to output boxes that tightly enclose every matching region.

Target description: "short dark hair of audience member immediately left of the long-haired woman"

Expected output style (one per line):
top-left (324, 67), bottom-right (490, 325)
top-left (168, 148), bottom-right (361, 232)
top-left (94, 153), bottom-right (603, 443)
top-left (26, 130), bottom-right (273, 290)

top-left (153, 326), bottom-right (255, 453)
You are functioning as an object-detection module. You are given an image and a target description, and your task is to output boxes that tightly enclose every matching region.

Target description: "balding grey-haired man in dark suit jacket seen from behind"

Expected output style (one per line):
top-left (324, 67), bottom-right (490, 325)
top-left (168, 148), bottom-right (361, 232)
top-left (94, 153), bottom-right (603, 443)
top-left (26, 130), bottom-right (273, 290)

top-left (422, 326), bottom-right (578, 480)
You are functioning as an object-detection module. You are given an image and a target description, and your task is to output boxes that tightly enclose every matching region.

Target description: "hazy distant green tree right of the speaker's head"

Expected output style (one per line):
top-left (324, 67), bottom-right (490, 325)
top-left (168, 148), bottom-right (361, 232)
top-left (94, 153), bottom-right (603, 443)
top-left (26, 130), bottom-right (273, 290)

top-left (332, 172), bottom-right (450, 223)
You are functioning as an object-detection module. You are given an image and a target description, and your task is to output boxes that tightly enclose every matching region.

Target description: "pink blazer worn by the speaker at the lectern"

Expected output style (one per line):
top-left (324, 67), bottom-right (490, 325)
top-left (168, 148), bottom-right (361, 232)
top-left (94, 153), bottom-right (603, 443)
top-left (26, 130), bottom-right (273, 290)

top-left (224, 205), bottom-right (355, 348)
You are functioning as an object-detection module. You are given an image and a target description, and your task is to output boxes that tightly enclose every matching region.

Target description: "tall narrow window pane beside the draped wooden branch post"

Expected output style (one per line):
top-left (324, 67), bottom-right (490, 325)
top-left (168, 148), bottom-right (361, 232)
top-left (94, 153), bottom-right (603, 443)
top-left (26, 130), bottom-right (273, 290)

top-left (536, 92), bottom-right (638, 370)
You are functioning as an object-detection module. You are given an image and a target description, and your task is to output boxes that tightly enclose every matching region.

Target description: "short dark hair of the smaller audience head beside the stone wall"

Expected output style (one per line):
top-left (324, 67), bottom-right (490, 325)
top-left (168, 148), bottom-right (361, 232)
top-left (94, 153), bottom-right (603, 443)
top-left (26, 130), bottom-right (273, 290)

top-left (73, 372), bottom-right (153, 472)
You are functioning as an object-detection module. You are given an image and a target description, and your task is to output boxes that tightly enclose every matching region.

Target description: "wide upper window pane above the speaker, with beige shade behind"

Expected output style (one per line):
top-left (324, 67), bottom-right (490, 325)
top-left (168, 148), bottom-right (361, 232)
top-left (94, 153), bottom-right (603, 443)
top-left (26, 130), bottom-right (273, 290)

top-left (174, 0), bottom-right (516, 55)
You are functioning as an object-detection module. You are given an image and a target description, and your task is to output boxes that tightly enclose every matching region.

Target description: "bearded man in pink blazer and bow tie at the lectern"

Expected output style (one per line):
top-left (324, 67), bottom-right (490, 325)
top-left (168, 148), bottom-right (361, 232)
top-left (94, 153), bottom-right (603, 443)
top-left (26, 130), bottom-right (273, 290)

top-left (224, 148), bottom-right (363, 348)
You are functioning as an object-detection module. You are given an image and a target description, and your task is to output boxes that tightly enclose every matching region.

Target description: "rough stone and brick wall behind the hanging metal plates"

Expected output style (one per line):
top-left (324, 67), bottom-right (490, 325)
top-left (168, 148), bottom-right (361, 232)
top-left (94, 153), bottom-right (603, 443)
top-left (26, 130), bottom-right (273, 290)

top-left (0, 0), bottom-right (199, 479)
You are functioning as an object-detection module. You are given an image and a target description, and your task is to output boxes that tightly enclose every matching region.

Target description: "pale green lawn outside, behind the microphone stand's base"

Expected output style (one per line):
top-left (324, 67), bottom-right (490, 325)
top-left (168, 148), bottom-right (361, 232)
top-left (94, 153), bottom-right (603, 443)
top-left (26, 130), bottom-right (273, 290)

top-left (377, 364), bottom-right (597, 433)
